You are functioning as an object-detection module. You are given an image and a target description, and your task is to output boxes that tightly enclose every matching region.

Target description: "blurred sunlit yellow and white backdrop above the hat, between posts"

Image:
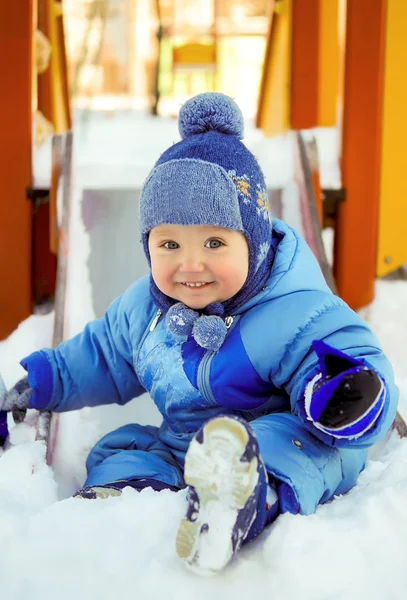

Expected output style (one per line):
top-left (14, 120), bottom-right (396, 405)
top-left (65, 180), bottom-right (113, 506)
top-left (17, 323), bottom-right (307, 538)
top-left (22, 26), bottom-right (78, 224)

top-left (64, 0), bottom-right (273, 117)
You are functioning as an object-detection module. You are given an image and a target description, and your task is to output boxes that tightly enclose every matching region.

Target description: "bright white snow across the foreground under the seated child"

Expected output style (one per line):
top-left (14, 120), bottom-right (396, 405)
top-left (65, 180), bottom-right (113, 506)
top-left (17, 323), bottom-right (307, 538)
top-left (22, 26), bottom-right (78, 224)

top-left (0, 434), bottom-right (407, 600)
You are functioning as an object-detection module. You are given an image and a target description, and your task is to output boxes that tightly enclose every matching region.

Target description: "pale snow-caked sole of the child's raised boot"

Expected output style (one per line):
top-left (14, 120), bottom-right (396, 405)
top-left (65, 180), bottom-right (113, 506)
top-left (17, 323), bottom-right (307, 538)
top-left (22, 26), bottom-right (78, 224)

top-left (176, 417), bottom-right (259, 575)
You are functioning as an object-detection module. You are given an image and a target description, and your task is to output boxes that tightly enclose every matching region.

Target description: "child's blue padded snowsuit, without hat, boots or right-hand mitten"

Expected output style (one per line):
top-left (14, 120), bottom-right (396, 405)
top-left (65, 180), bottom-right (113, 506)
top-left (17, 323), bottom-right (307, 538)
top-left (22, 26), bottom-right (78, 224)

top-left (22, 219), bottom-right (398, 514)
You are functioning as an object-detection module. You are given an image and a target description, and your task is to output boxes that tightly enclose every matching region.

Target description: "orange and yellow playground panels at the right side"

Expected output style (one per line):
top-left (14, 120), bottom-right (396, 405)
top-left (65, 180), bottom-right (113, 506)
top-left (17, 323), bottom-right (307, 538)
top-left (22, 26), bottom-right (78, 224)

top-left (257, 0), bottom-right (407, 309)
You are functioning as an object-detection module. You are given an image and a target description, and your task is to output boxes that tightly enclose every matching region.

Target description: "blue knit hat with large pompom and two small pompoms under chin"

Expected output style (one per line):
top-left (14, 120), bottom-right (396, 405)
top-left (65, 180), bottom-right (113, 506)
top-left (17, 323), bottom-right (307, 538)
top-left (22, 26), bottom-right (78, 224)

top-left (140, 93), bottom-right (272, 351)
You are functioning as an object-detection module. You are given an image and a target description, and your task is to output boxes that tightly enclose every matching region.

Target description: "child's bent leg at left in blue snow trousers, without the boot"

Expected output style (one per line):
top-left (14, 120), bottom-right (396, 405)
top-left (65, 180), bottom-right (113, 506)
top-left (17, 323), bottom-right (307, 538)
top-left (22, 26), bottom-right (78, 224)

top-left (81, 424), bottom-right (184, 489)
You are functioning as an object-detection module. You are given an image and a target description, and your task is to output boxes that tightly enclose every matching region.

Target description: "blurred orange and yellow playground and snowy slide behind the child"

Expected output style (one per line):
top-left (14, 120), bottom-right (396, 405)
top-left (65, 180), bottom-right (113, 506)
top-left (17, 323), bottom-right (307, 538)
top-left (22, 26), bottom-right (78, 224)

top-left (0, 0), bottom-right (407, 378)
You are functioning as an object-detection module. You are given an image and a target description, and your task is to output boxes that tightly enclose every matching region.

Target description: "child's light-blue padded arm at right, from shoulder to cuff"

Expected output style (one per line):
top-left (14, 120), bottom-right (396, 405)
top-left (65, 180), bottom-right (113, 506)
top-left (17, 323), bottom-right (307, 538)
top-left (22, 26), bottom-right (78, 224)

top-left (240, 290), bottom-right (398, 447)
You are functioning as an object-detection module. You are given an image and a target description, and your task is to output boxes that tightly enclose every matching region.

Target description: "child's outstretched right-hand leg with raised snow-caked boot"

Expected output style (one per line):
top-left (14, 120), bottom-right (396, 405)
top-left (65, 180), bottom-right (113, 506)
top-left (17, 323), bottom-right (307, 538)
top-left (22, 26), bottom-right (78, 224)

top-left (177, 413), bottom-right (366, 574)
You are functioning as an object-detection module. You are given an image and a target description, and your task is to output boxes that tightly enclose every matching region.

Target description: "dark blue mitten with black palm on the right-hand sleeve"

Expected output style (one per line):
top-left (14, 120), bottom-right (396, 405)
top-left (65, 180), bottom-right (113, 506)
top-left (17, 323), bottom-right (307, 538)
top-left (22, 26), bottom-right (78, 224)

top-left (305, 341), bottom-right (386, 438)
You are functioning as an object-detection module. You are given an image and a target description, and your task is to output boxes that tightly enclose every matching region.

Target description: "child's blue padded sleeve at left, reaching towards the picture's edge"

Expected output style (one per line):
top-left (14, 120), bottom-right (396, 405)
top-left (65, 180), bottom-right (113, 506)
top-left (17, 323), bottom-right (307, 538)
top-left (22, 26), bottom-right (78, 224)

top-left (9, 280), bottom-right (154, 412)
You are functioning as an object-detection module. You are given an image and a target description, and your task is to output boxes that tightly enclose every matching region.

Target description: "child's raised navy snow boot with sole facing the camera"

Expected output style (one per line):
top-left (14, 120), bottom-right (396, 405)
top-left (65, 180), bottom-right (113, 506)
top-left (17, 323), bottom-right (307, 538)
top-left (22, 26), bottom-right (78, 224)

top-left (176, 417), bottom-right (268, 575)
